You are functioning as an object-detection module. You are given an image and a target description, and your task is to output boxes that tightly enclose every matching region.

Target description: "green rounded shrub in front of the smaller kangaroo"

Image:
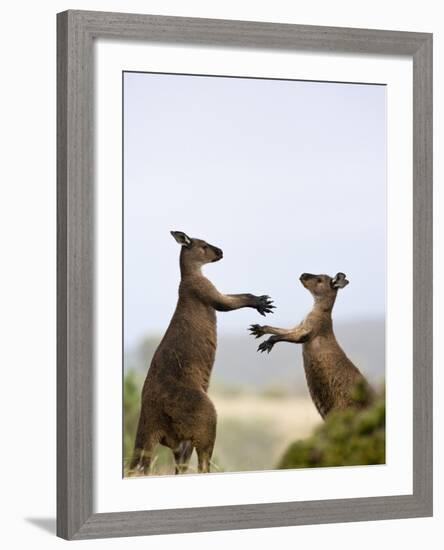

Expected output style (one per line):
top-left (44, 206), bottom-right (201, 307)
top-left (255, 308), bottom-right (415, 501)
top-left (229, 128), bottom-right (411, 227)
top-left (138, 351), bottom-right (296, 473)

top-left (277, 397), bottom-right (385, 469)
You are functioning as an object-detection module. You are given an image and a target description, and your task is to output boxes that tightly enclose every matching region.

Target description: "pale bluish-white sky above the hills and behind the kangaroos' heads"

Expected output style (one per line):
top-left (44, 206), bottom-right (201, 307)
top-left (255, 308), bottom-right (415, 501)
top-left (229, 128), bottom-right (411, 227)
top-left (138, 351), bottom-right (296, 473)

top-left (124, 73), bottom-right (386, 347)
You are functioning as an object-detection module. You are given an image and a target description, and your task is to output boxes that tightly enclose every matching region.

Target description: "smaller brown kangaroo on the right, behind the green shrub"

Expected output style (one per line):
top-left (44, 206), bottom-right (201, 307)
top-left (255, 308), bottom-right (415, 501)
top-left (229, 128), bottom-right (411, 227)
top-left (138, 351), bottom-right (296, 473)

top-left (249, 273), bottom-right (373, 418)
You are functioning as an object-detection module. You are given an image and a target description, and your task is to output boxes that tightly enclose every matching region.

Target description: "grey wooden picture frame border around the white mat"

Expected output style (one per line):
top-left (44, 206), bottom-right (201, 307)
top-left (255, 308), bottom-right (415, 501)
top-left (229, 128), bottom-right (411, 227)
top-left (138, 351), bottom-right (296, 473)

top-left (57, 11), bottom-right (433, 539)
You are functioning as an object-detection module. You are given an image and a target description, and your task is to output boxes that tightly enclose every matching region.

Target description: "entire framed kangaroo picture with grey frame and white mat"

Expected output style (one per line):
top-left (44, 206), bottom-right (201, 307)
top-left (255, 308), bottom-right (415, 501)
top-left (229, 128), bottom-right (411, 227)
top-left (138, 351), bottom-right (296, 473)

top-left (57, 11), bottom-right (432, 539)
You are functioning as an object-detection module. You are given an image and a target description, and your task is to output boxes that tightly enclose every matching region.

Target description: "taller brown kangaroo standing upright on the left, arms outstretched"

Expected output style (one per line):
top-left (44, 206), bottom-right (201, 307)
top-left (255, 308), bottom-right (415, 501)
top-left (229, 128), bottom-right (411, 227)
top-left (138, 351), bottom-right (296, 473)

top-left (130, 231), bottom-right (274, 474)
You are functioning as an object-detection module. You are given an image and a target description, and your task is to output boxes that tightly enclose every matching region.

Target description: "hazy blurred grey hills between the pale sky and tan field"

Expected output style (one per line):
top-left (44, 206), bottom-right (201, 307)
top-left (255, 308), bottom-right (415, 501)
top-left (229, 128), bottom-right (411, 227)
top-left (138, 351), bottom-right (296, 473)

top-left (124, 318), bottom-right (385, 396)
